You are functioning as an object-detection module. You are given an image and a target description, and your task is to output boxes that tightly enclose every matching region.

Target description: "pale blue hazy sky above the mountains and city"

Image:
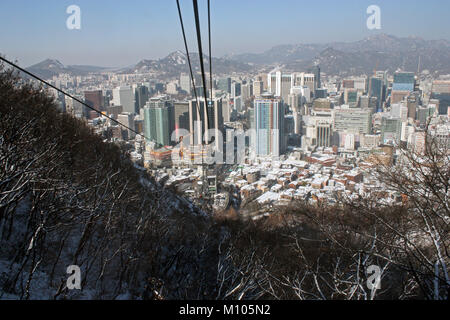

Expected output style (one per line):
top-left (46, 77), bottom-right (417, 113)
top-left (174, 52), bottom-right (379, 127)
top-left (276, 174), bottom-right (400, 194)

top-left (0, 0), bottom-right (450, 67)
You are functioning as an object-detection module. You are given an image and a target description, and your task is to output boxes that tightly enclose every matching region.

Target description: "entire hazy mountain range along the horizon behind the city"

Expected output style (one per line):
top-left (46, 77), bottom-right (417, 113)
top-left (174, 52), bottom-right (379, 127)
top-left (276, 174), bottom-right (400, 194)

top-left (27, 34), bottom-right (450, 78)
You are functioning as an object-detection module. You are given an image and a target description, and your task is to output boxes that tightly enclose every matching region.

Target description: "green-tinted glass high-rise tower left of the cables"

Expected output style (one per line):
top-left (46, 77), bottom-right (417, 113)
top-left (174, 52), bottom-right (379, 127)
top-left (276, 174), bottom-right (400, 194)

top-left (144, 96), bottom-right (175, 146)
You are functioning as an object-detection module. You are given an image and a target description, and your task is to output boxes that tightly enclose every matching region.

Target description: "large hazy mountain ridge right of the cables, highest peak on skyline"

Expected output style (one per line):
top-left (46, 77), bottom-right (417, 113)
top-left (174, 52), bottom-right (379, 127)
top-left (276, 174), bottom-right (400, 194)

top-left (226, 34), bottom-right (450, 74)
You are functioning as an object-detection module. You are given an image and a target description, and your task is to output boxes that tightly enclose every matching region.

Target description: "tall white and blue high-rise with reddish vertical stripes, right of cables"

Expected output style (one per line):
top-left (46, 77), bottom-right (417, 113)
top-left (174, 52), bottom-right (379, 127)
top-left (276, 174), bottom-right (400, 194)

top-left (252, 94), bottom-right (285, 156)
